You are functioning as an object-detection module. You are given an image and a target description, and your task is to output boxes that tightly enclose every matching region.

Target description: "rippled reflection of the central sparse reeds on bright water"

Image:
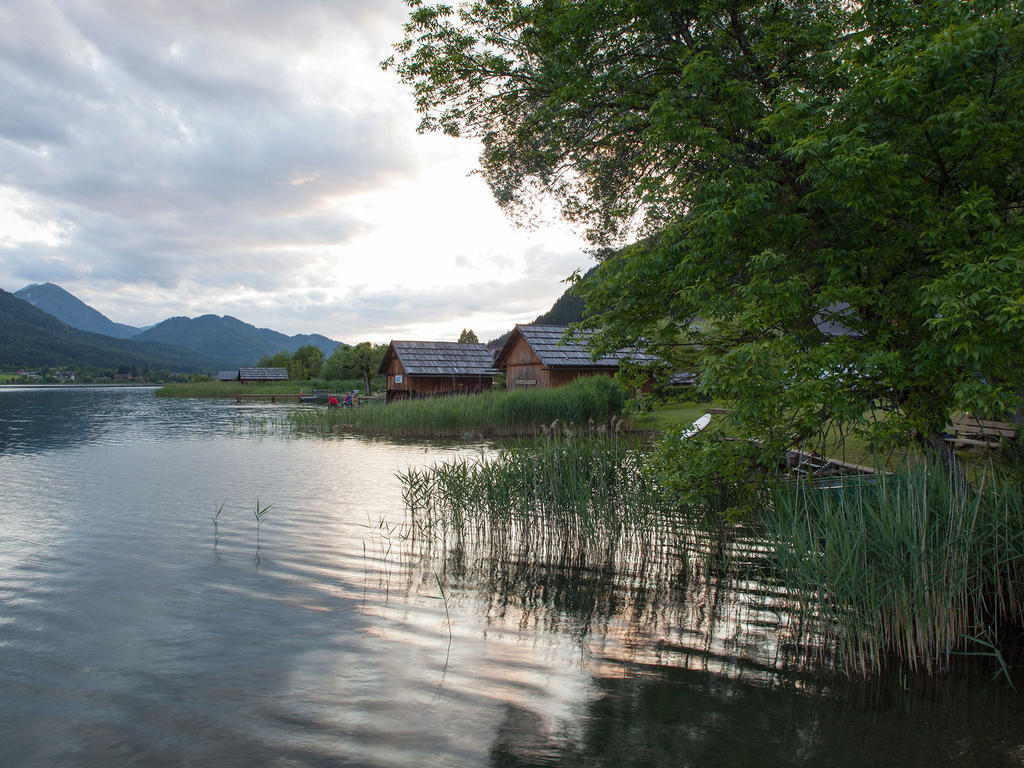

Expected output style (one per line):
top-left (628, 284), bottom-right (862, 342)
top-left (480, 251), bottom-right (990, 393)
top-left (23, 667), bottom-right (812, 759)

top-left (395, 519), bottom-right (802, 680)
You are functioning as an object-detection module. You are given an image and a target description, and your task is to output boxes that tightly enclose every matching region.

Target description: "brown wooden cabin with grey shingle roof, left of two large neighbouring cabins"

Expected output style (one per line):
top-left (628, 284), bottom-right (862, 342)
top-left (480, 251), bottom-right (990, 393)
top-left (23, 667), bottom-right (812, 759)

top-left (377, 341), bottom-right (498, 402)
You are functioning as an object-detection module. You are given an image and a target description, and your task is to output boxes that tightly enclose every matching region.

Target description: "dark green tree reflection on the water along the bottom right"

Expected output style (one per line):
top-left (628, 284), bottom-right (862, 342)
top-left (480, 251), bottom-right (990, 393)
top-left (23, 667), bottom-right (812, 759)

top-left (481, 666), bottom-right (1024, 768)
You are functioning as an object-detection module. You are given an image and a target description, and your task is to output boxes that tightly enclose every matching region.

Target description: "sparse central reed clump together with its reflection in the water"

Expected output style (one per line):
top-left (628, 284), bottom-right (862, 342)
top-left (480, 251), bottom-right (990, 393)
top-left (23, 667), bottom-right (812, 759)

top-left (398, 433), bottom-right (800, 672)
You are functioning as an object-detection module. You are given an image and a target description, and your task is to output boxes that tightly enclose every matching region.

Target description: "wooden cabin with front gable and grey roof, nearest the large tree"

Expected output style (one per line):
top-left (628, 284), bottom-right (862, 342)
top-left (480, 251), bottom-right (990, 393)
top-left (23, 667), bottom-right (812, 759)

top-left (495, 325), bottom-right (654, 389)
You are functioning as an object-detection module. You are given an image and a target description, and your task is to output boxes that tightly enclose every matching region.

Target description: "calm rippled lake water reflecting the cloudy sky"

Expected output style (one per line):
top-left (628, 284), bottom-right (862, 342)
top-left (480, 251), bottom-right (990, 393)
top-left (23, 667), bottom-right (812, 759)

top-left (0, 388), bottom-right (1024, 768)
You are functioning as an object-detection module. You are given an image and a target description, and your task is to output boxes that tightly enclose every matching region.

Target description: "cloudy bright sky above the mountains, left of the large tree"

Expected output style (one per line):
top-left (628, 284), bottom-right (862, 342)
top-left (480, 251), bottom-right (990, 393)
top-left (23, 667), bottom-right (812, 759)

top-left (0, 0), bottom-right (593, 343)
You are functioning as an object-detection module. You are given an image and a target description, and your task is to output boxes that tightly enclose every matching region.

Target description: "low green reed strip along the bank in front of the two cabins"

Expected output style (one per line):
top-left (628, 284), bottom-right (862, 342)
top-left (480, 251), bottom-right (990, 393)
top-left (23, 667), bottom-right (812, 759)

top-left (291, 377), bottom-right (627, 437)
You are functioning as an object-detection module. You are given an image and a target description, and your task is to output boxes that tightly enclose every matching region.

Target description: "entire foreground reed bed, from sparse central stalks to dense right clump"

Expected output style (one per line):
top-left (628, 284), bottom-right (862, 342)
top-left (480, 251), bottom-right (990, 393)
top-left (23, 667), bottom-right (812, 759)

top-left (399, 434), bottom-right (1024, 679)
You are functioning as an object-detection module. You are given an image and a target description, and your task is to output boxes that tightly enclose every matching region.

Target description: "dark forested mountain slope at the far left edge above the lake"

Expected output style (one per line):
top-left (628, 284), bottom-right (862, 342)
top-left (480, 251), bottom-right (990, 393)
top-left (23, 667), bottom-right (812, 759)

top-left (0, 289), bottom-right (217, 373)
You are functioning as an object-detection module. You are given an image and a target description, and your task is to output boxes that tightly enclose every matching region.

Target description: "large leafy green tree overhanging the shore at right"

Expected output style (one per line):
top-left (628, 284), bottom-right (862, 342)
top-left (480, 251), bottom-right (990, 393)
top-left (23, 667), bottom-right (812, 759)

top-left (388, 0), bottom-right (1024, 483)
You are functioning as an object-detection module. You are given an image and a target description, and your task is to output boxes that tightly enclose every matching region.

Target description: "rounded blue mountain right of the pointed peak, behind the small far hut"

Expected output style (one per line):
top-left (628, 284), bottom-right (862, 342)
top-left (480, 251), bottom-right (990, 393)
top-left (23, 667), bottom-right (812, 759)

top-left (134, 314), bottom-right (341, 368)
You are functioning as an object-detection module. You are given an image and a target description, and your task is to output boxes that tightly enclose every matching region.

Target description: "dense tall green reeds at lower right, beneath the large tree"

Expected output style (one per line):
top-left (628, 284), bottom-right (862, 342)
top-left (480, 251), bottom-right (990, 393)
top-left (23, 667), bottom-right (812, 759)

top-left (764, 463), bottom-right (1024, 677)
